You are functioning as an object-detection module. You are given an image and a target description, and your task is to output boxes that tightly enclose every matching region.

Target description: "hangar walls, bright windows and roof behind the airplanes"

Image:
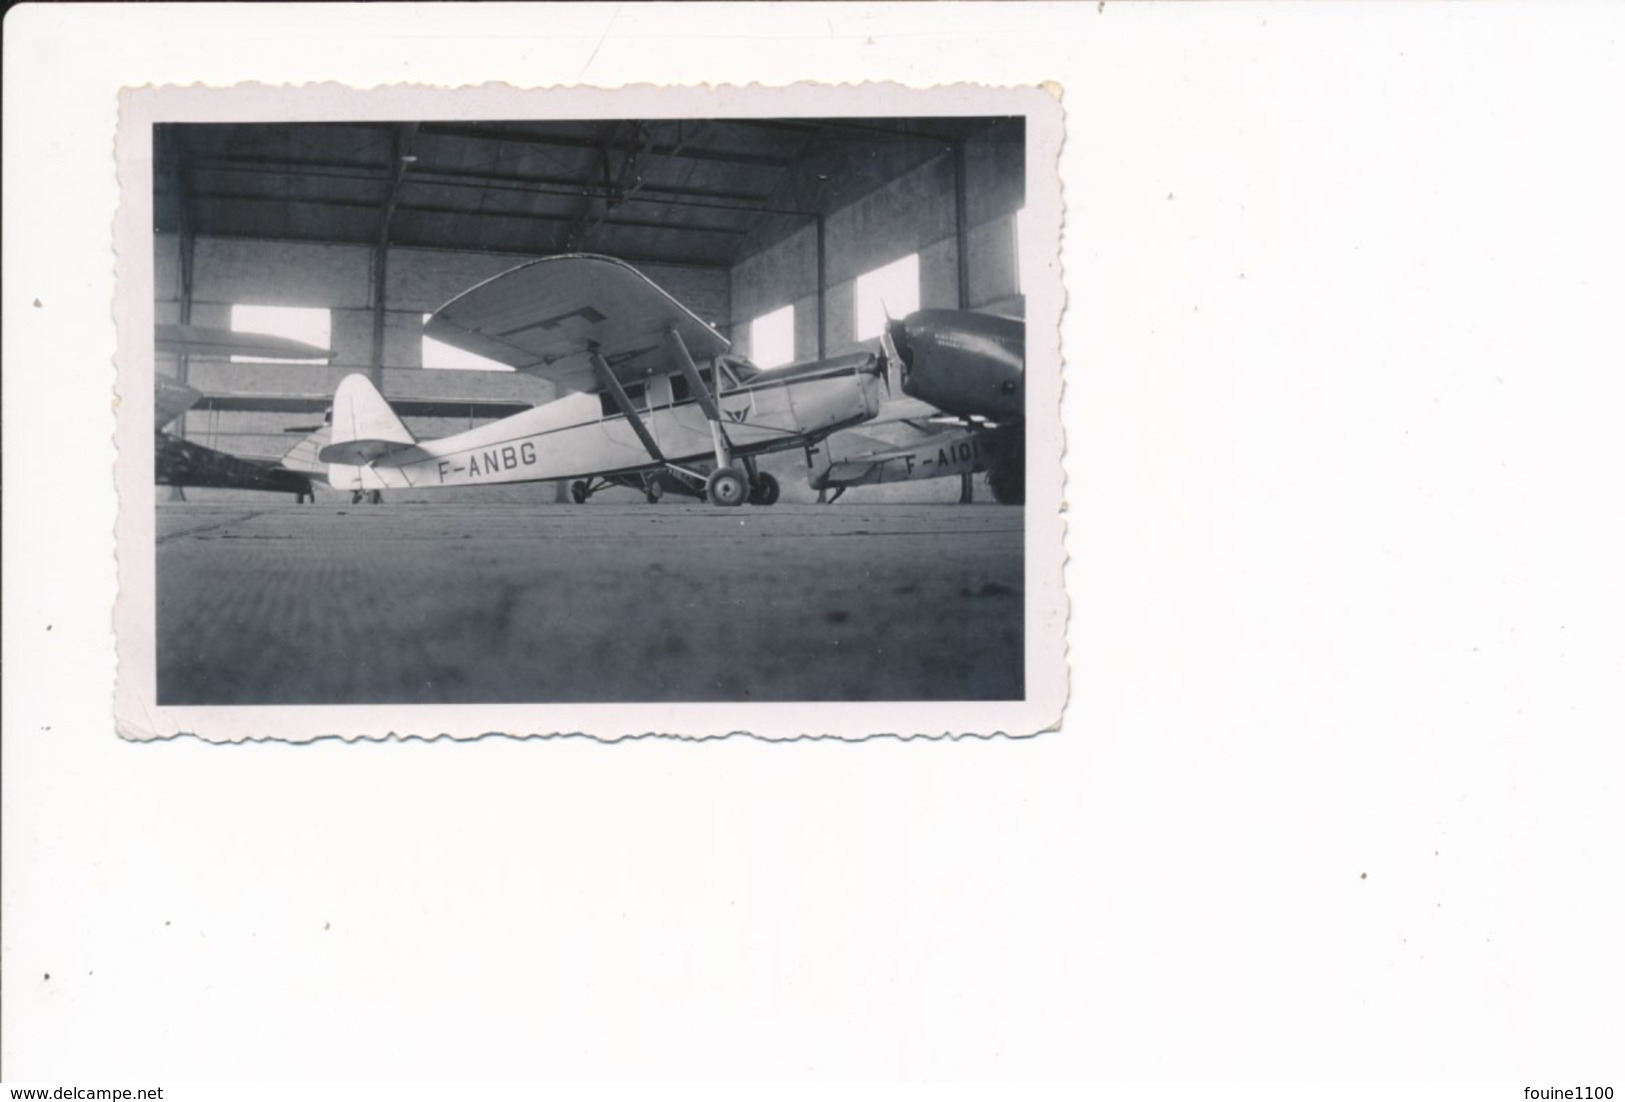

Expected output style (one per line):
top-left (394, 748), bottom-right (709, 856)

top-left (153, 117), bottom-right (1025, 502)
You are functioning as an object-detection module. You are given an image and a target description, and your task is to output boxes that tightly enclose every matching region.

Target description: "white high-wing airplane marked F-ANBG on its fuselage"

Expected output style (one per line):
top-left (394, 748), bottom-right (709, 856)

top-left (319, 254), bottom-right (886, 505)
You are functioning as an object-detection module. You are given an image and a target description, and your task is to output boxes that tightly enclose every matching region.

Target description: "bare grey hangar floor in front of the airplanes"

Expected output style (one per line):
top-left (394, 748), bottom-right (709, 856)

top-left (158, 502), bottom-right (1024, 705)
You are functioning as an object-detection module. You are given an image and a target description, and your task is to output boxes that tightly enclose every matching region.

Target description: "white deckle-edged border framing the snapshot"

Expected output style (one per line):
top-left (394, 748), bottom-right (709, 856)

top-left (114, 83), bottom-right (1069, 741)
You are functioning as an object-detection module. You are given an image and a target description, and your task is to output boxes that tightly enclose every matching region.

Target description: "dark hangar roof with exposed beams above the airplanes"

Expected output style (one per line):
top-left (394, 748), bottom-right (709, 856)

top-left (154, 117), bottom-right (1022, 268)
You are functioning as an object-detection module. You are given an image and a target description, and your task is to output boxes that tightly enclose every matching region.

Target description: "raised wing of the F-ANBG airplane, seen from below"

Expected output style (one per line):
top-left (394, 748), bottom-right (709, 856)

top-left (424, 254), bottom-right (728, 392)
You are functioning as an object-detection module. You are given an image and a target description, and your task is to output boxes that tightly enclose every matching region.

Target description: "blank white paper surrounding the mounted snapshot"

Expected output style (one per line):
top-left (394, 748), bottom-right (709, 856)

top-left (3, 3), bottom-right (1625, 1084)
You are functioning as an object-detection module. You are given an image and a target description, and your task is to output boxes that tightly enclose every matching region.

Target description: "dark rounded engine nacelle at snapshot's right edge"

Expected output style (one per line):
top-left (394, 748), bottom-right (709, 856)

top-left (886, 310), bottom-right (1027, 419)
